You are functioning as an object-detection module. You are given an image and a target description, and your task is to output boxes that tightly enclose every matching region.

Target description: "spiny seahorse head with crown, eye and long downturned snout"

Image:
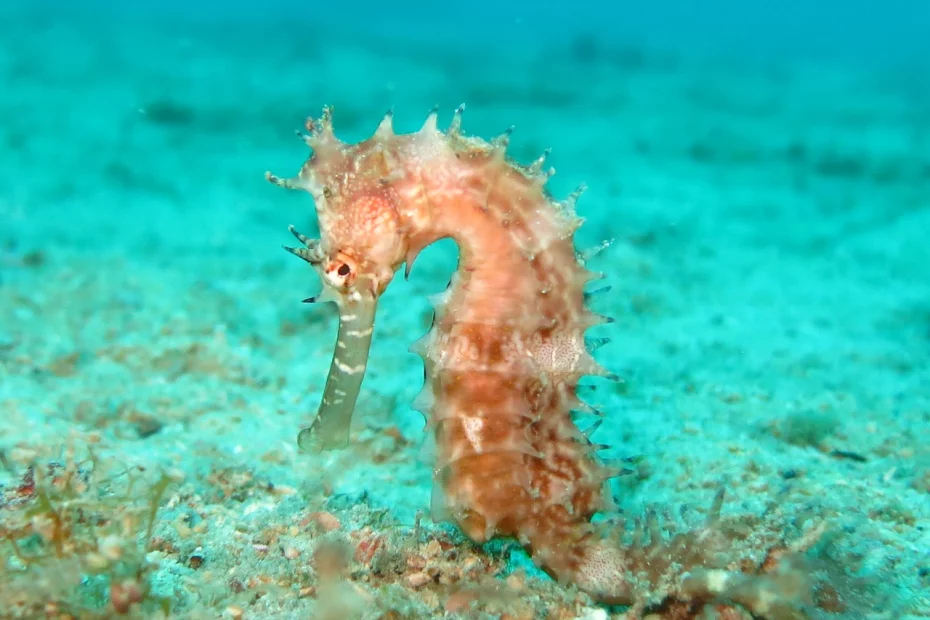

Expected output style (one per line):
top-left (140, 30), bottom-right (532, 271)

top-left (267, 108), bottom-right (408, 450)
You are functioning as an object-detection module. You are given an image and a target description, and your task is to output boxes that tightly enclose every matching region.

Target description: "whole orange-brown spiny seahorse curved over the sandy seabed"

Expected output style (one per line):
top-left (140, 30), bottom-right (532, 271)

top-left (269, 108), bottom-right (629, 601)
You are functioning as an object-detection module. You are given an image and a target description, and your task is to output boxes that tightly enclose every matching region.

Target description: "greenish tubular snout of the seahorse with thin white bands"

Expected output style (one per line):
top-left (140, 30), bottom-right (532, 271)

top-left (297, 297), bottom-right (377, 452)
